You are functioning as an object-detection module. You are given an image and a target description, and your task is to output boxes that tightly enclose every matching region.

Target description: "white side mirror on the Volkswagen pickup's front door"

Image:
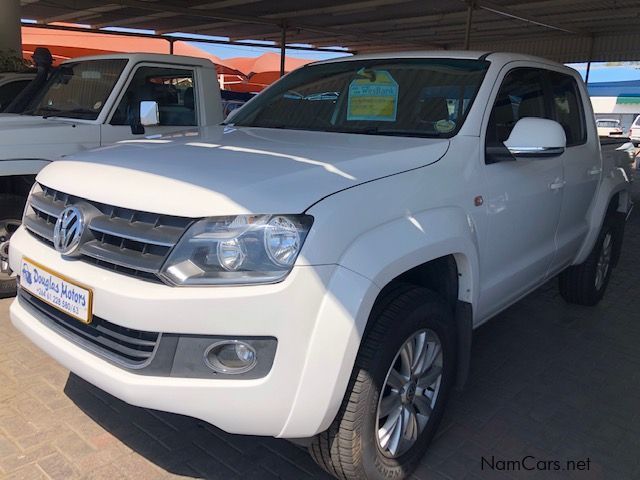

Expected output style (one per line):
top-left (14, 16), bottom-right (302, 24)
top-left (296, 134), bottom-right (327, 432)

top-left (504, 117), bottom-right (567, 159)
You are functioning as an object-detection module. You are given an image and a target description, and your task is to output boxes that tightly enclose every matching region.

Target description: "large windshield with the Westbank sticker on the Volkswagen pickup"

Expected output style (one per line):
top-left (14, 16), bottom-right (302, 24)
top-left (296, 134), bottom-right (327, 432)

top-left (228, 58), bottom-right (489, 137)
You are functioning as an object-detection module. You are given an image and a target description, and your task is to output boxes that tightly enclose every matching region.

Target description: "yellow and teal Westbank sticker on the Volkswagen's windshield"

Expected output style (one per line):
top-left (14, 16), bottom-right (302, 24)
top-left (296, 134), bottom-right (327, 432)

top-left (347, 68), bottom-right (398, 122)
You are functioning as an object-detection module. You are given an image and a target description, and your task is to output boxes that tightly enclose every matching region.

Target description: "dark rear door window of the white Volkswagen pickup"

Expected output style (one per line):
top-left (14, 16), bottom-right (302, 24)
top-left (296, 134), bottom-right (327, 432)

top-left (549, 72), bottom-right (587, 147)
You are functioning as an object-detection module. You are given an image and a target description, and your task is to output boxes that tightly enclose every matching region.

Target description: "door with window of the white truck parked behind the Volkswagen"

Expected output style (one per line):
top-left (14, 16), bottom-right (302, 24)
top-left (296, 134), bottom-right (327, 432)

top-left (101, 65), bottom-right (199, 145)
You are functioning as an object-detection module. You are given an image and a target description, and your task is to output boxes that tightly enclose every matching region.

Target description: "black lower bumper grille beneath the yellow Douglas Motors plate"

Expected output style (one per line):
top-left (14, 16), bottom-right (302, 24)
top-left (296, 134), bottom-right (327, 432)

top-left (18, 289), bottom-right (161, 369)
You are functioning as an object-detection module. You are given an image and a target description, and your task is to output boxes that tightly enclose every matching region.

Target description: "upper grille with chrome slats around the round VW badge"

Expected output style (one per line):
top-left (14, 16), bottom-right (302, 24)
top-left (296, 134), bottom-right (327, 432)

top-left (24, 185), bottom-right (192, 282)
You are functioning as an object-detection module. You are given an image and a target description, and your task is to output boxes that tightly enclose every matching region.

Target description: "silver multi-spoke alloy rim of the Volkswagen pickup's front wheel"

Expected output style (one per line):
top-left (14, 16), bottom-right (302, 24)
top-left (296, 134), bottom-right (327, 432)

top-left (376, 329), bottom-right (443, 458)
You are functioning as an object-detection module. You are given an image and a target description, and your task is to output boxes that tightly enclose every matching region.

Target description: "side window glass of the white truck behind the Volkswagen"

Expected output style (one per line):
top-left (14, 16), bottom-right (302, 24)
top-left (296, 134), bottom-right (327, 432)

top-left (111, 67), bottom-right (197, 126)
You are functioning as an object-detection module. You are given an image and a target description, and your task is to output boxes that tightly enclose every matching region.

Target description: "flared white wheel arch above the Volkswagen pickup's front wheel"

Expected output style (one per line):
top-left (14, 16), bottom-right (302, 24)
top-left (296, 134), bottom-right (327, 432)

top-left (338, 207), bottom-right (479, 305)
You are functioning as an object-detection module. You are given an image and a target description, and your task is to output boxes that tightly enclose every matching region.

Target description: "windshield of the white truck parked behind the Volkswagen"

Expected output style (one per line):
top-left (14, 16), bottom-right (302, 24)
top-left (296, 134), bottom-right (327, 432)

top-left (24, 59), bottom-right (127, 120)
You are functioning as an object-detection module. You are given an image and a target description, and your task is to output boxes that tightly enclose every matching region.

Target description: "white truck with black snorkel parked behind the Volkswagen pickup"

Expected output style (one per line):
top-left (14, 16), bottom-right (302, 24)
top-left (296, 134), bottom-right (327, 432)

top-left (0, 54), bottom-right (222, 298)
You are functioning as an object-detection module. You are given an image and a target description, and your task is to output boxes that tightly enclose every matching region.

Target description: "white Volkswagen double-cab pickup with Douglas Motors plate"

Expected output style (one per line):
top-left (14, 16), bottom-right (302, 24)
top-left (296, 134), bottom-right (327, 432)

top-left (10, 52), bottom-right (631, 479)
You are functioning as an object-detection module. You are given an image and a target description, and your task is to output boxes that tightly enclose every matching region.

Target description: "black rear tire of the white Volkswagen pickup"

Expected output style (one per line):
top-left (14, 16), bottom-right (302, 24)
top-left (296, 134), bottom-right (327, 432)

top-left (559, 212), bottom-right (624, 306)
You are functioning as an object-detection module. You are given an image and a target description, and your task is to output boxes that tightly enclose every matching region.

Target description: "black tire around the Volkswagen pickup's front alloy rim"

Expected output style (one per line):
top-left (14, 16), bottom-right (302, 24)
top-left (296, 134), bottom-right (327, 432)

top-left (309, 285), bottom-right (456, 480)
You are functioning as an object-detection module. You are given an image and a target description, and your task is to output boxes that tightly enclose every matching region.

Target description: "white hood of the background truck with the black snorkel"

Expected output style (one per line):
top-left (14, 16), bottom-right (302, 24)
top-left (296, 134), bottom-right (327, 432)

top-left (0, 114), bottom-right (100, 160)
